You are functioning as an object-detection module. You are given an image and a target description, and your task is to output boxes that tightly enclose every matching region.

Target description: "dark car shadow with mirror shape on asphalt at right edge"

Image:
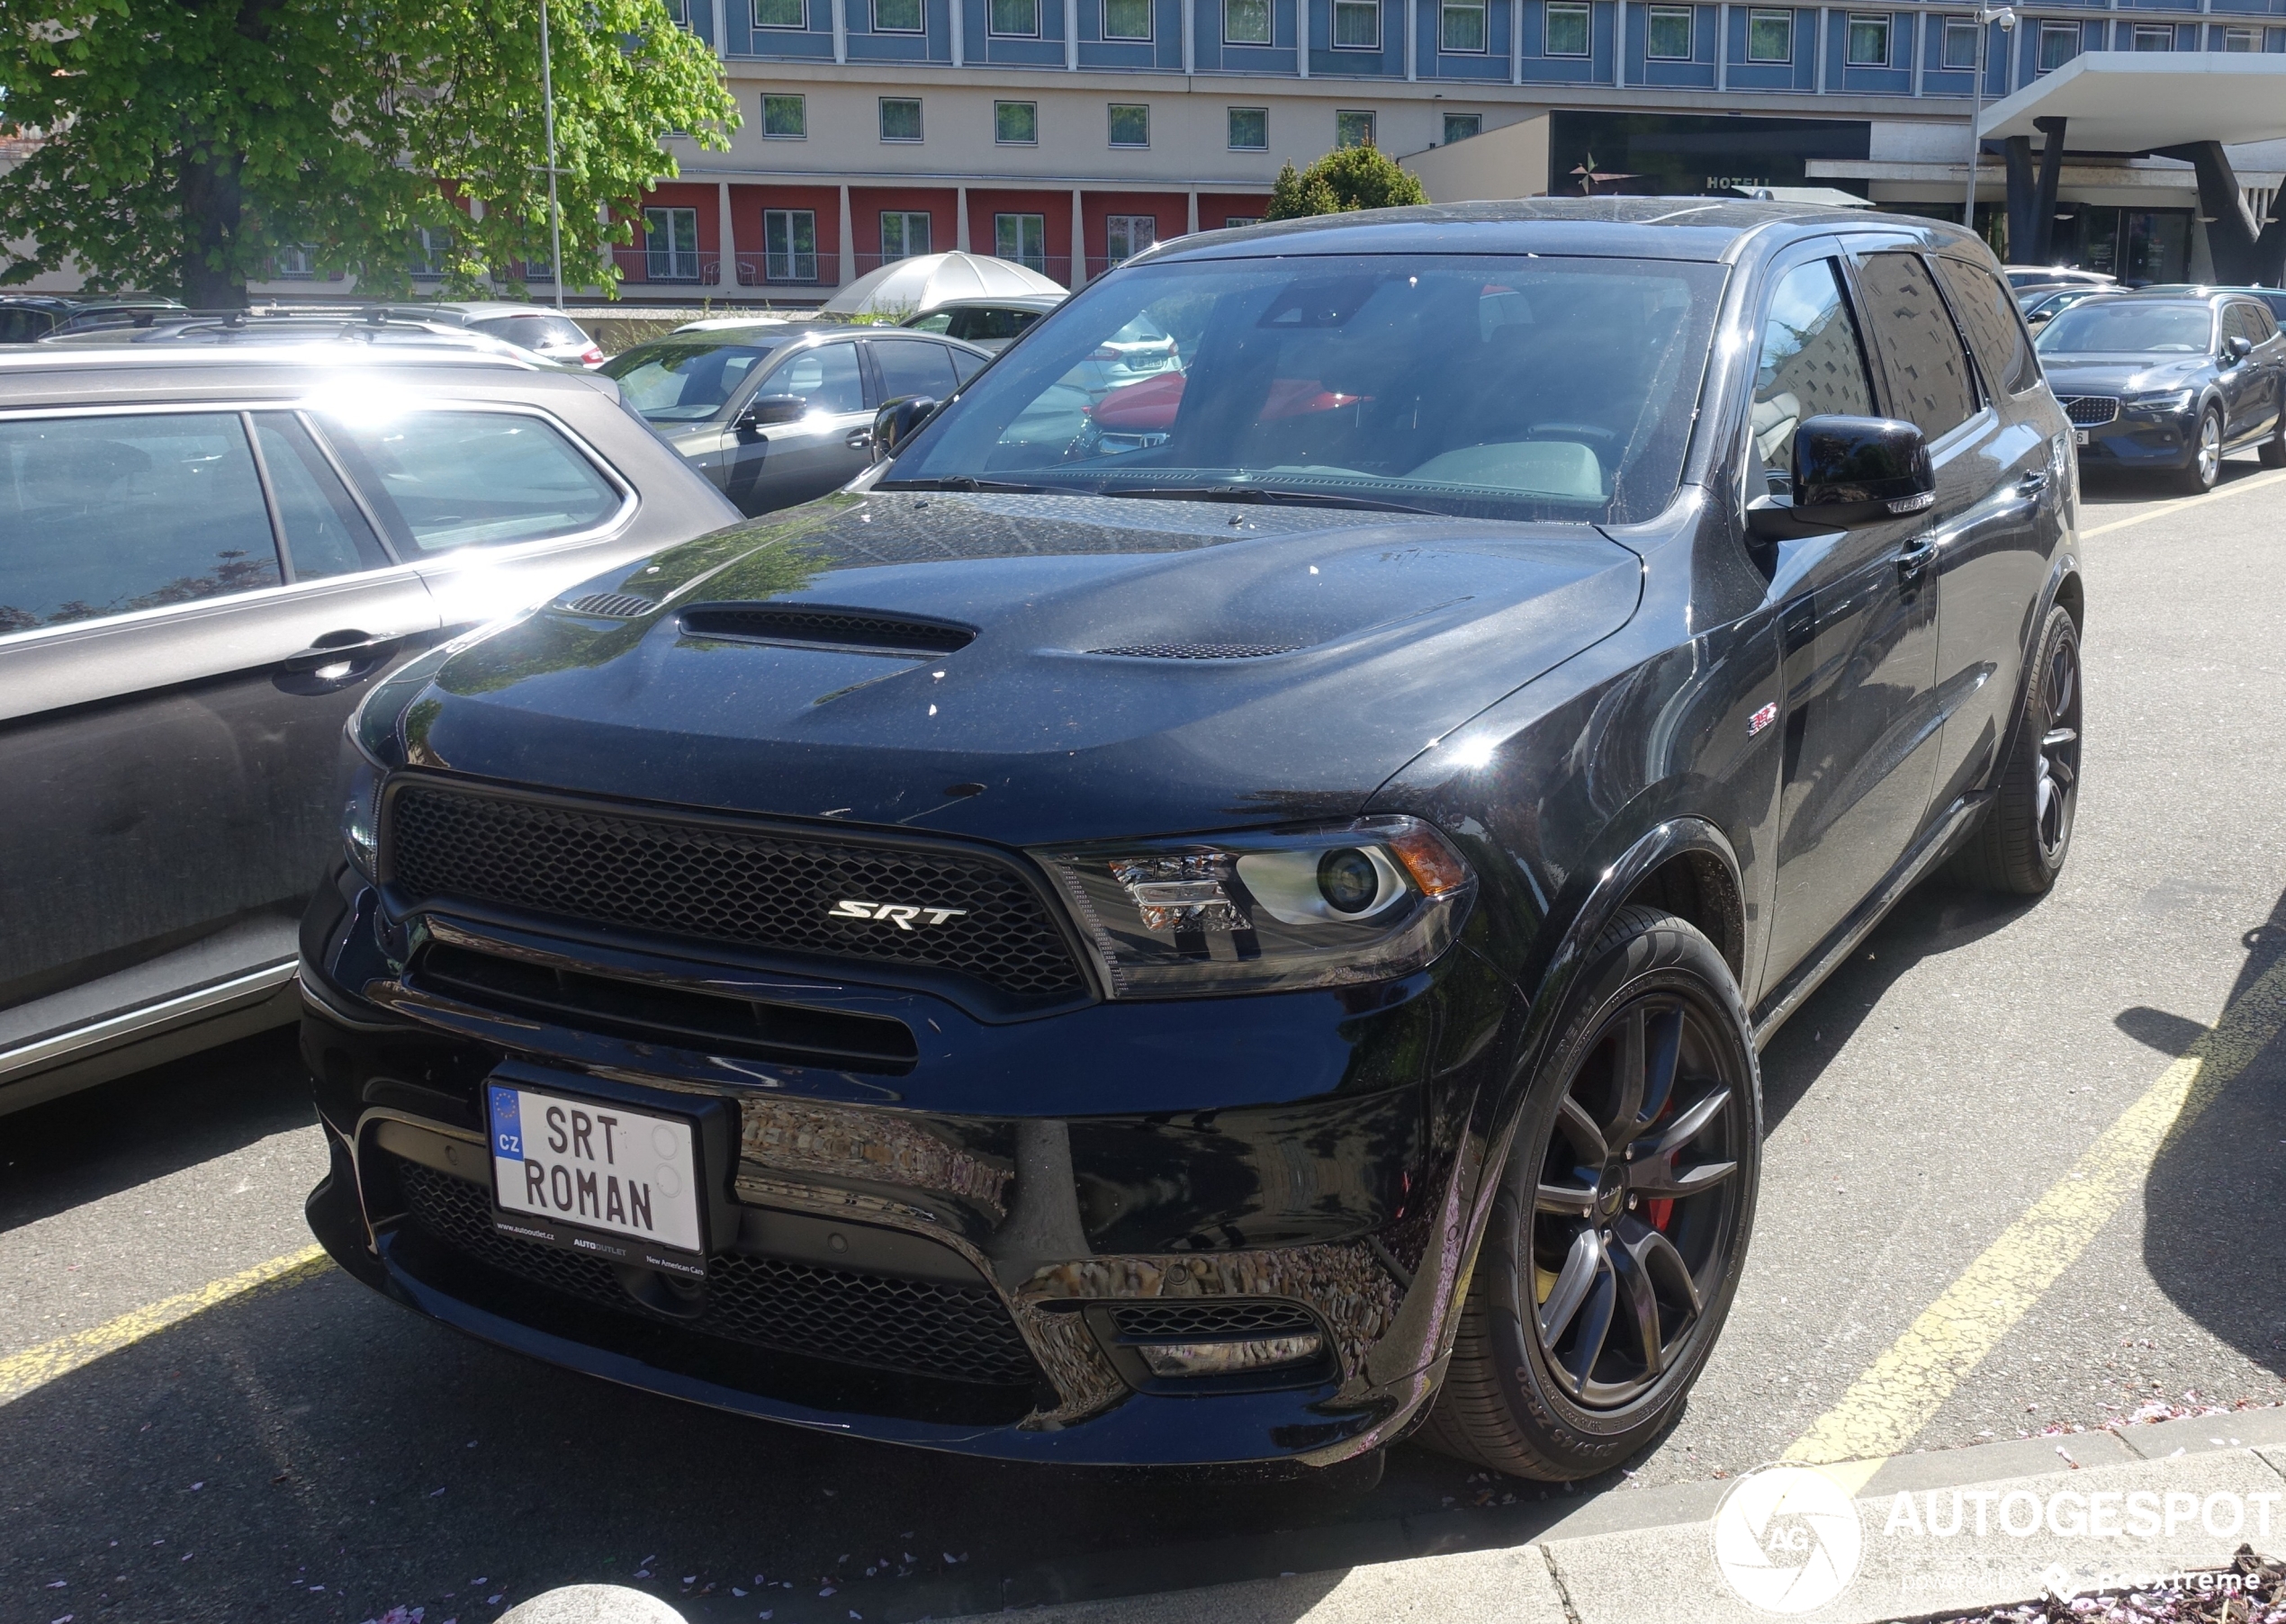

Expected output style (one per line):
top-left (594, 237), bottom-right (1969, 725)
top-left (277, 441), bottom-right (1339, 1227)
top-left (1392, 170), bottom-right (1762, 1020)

top-left (2115, 881), bottom-right (2286, 1403)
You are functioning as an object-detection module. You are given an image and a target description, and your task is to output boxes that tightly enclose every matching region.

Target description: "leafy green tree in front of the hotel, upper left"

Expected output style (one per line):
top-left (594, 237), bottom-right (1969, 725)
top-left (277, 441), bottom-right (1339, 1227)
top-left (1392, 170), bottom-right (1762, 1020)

top-left (0, 0), bottom-right (738, 306)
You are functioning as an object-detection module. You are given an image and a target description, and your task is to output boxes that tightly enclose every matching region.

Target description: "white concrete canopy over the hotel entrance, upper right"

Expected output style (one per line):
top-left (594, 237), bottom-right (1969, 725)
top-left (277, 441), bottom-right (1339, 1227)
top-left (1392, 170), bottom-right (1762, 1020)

top-left (1977, 50), bottom-right (2286, 153)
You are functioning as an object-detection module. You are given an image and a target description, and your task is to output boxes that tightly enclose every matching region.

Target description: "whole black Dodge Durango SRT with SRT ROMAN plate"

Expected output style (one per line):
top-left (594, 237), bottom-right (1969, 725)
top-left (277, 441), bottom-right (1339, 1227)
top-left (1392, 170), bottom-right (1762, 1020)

top-left (302, 199), bottom-right (2083, 1478)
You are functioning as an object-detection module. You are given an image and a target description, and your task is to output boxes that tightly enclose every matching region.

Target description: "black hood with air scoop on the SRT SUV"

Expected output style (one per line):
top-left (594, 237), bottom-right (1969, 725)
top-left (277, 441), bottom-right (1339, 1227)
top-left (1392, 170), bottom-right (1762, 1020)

top-left (405, 491), bottom-right (1642, 843)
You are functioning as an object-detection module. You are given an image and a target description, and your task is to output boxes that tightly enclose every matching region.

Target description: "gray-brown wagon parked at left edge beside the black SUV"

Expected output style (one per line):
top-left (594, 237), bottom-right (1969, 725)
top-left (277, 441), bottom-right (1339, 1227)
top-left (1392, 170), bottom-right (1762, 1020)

top-left (0, 343), bottom-right (736, 1112)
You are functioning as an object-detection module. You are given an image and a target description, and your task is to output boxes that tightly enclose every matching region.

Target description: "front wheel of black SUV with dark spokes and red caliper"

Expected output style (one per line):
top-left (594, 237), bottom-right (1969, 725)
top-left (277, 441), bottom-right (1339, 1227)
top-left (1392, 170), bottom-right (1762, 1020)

top-left (1422, 907), bottom-right (1762, 1483)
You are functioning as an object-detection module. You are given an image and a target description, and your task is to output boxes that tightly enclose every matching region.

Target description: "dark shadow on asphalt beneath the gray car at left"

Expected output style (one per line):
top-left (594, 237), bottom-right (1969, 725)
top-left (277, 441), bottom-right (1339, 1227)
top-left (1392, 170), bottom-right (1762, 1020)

top-left (0, 1026), bottom-right (316, 1234)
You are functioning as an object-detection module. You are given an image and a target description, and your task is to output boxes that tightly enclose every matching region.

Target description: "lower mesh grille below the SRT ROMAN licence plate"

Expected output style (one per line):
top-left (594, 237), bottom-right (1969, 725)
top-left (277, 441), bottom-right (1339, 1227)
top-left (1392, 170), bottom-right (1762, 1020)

top-left (380, 1151), bottom-right (1038, 1386)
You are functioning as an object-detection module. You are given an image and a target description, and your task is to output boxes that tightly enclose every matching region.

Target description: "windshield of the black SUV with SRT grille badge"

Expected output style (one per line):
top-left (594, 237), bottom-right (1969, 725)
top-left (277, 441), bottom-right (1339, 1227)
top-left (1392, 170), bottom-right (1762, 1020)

top-left (882, 254), bottom-right (1724, 521)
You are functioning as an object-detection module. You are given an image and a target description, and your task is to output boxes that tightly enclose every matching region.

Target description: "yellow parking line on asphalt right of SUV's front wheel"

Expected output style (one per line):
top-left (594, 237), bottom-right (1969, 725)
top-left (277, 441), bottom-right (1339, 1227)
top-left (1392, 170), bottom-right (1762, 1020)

top-left (1786, 959), bottom-right (2286, 1464)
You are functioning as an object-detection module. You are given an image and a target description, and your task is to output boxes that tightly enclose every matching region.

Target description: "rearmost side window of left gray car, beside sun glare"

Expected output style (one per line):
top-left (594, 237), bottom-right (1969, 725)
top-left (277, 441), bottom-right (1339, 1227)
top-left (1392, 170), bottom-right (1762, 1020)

top-left (320, 411), bottom-right (619, 557)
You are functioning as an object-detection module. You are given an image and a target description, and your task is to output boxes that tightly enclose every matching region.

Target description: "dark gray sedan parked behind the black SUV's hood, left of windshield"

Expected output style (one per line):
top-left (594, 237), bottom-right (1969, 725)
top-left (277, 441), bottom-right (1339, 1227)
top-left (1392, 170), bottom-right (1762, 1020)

top-left (601, 322), bottom-right (990, 514)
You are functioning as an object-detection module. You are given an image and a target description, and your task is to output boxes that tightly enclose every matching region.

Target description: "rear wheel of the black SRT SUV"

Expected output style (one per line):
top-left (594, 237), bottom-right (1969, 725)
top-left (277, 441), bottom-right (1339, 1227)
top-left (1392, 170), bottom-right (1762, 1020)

top-left (1946, 606), bottom-right (2084, 898)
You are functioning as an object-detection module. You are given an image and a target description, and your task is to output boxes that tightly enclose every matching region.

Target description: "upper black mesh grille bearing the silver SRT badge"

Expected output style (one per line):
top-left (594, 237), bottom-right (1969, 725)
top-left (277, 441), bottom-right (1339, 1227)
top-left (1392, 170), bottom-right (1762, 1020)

top-left (382, 784), bottom-right (1086, 1002)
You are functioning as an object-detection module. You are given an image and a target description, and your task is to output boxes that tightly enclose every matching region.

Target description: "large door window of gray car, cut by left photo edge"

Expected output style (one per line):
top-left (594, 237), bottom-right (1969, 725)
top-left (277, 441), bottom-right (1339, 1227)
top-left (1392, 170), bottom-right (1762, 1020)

top-left (0, 411), bottom-right (279, 635)
